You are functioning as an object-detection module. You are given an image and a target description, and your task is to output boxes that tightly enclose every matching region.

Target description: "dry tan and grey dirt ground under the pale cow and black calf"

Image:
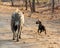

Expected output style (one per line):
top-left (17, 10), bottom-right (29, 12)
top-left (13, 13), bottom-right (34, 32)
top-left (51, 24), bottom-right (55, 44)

top-left (0, 6), bottom-right (60, 48)
